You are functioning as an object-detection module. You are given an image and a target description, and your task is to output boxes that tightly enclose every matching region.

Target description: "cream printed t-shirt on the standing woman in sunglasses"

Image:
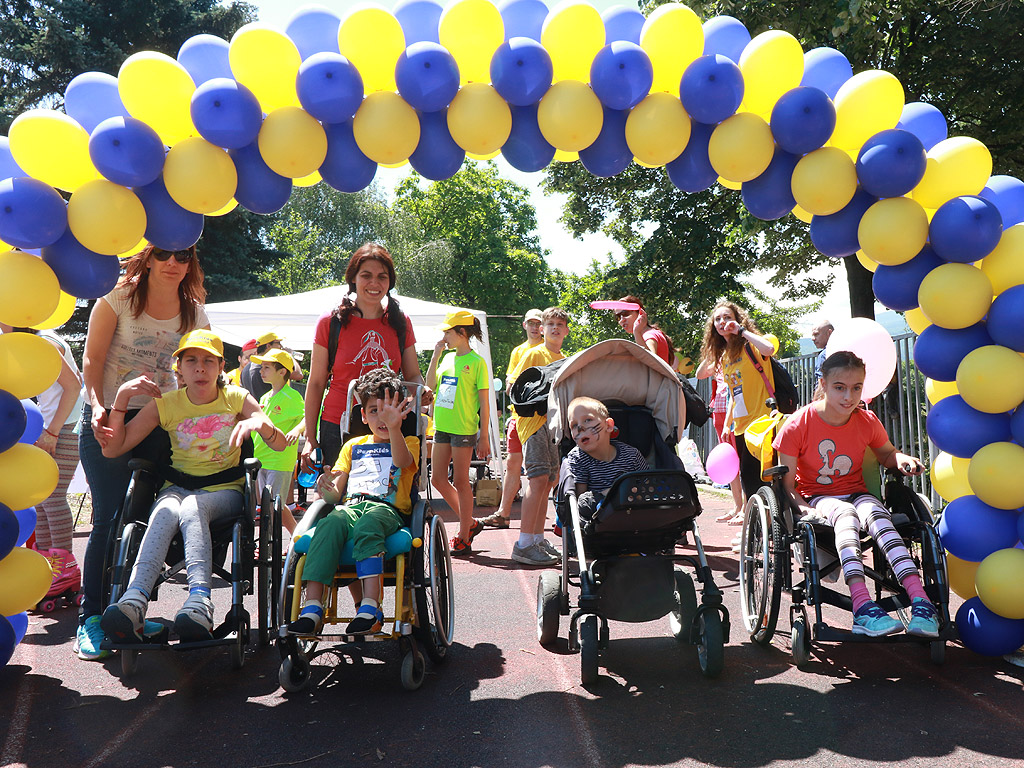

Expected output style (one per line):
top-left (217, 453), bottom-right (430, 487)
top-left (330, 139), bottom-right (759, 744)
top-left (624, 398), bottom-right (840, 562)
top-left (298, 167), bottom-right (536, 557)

top-left (100, 286), bottom-right (210, 409)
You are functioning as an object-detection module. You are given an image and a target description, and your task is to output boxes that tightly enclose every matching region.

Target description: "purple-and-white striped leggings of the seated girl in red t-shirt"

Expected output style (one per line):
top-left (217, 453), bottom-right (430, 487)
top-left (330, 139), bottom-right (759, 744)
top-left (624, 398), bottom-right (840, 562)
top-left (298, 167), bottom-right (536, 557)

top-left (809, 493), bottom-right (918, 584)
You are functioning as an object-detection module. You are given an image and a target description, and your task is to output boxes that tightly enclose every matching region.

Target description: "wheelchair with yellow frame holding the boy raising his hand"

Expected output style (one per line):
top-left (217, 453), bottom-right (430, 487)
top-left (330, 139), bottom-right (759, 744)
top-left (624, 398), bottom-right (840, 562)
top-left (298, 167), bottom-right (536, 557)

top-left (276, 382), bottom-right (455, 692)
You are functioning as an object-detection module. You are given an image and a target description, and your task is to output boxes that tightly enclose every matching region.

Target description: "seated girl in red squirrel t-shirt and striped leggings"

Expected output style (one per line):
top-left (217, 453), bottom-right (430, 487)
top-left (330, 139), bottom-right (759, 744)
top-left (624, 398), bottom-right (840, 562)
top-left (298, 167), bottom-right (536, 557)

top-left (772, 351), bottom-right (939, 637)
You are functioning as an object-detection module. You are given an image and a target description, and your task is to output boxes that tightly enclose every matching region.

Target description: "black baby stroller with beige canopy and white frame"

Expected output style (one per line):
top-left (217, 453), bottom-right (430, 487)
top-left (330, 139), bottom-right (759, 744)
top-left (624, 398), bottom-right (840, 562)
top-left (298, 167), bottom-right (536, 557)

top-left (537, 339), bottom-right (729, 685)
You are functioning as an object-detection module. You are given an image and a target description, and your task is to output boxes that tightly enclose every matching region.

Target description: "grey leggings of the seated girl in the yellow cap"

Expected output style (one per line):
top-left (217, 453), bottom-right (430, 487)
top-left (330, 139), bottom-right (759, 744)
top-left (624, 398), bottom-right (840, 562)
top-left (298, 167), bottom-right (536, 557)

top-left (128, 485), bottom-right (242, 596)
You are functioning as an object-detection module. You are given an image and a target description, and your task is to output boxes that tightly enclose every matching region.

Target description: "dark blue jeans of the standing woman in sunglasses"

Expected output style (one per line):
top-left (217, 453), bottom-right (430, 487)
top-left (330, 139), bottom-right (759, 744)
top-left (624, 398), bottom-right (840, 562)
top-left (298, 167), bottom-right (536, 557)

top-left (78, 404), bottom-right (168, 622)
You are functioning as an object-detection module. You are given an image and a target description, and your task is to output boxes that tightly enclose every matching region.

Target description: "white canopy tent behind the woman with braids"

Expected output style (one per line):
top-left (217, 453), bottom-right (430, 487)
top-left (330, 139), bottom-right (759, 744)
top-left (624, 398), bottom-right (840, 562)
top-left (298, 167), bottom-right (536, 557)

top-left (206, 286), bottom-right (503, 476)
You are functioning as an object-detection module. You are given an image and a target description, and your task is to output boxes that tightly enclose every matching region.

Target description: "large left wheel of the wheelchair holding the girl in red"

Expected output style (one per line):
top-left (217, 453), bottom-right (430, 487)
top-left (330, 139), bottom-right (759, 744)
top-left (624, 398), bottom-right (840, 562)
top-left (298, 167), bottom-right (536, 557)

top-left (739, 487), bottom-right (785, 645)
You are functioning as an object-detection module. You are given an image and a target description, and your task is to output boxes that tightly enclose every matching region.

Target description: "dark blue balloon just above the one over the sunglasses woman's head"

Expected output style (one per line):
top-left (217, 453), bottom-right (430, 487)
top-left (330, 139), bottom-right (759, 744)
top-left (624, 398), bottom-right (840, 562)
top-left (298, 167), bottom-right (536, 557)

top-left (89, 118), bottom-right (166, 186)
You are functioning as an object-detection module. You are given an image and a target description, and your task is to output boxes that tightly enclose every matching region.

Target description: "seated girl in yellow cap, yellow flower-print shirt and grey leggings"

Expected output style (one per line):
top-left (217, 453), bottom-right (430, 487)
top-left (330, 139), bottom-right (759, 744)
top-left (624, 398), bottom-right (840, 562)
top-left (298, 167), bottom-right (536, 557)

top-left (100, 331), bottom-right (287, 642)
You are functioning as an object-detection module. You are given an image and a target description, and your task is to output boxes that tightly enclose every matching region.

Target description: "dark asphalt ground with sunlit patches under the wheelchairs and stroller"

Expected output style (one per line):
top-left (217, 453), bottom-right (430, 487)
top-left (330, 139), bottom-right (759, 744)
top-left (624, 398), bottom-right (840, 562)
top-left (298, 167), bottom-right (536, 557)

top-left (0, 489), bottom-right (1024, 768)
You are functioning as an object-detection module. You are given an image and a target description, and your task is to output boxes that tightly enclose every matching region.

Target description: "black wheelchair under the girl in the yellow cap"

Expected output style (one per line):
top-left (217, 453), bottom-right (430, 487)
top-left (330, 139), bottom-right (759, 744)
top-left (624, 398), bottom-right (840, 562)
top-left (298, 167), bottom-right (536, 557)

top-left (100, 440), bottom-right (282, 677)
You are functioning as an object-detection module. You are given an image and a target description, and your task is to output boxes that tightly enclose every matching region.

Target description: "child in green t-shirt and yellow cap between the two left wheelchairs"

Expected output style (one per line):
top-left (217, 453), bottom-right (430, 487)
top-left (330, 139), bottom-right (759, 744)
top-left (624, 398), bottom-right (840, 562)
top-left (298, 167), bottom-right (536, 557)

top-left (252, 349), bottom-right (305, 534)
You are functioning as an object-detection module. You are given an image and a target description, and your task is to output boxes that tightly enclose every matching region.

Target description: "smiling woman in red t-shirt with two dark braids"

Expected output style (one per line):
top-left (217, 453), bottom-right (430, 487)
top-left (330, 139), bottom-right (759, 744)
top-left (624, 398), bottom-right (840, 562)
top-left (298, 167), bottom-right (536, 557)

top-left (302, 243), bottom-right (429, 468)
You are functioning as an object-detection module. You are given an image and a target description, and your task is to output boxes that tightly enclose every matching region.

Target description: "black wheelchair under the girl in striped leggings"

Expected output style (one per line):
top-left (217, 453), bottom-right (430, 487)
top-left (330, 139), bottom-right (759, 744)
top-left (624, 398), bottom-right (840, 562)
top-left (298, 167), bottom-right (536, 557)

top-left (739, 415), bottom-right (956, 667)
